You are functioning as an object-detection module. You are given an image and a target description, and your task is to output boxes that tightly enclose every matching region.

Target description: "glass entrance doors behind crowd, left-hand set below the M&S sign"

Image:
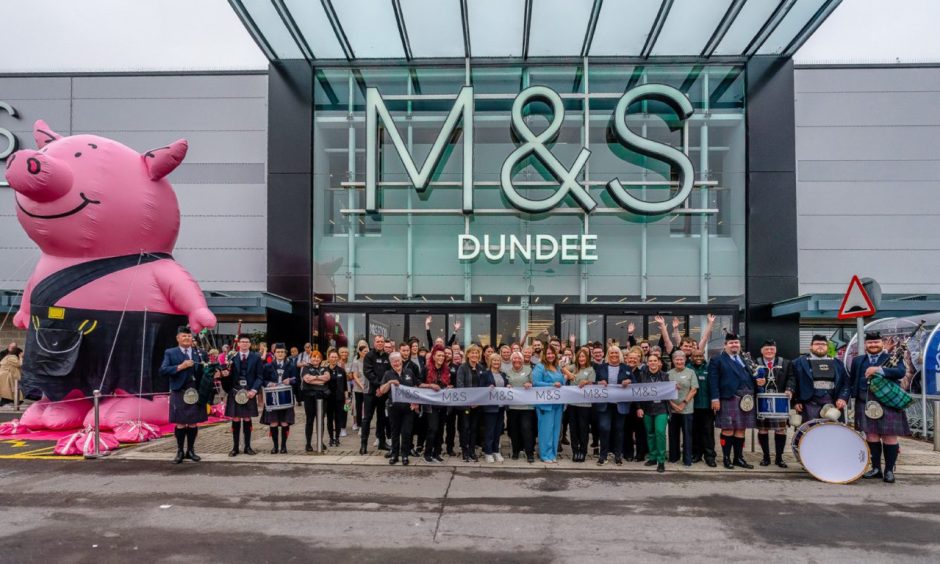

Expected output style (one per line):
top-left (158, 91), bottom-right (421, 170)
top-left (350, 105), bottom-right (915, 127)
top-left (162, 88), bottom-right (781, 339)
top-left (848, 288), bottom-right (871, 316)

top-left (316, 303), bottom-right (496, 351)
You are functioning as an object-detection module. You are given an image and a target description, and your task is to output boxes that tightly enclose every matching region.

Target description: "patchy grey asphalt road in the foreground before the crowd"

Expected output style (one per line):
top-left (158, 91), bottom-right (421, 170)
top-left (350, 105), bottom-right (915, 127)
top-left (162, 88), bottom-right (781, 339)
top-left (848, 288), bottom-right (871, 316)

top-left (0, 460), bottom-right (940, 564)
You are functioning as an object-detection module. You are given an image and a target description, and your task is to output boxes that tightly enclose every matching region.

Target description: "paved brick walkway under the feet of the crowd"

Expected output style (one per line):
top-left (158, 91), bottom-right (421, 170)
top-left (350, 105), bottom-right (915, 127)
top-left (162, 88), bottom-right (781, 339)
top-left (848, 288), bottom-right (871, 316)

top-left (112, 409), bottom-right (940, 475)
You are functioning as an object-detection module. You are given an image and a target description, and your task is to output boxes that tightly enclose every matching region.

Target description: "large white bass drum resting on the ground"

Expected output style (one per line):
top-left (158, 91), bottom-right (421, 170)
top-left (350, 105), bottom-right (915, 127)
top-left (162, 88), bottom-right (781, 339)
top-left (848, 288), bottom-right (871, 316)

top-left (793, 419), bottom-right (871, 484)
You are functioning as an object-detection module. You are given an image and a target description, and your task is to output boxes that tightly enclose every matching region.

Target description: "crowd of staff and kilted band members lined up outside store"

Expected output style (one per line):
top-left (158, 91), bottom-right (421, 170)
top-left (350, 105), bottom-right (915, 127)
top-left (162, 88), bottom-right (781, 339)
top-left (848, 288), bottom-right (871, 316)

top-left (164, 315), bottom-right (910, 482)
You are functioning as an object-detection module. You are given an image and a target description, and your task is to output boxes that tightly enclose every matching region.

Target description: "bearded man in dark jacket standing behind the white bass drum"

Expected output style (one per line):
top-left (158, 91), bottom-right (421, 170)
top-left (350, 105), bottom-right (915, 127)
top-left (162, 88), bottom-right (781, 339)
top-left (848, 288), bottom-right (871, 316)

top-left (787, 335), bottom-right (851, 421)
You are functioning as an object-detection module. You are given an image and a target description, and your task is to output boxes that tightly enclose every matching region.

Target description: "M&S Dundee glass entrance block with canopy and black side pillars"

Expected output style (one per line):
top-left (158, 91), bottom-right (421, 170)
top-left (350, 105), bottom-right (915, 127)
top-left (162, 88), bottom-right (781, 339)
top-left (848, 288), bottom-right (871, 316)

top-left (242, 0), bottom-right (837, 352)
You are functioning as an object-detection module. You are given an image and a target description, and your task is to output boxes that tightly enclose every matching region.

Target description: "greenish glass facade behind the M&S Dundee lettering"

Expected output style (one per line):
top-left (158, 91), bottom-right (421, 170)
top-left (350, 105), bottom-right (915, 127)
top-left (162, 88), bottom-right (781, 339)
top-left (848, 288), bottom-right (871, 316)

top-left (313, 62), bottom-right (745, 341)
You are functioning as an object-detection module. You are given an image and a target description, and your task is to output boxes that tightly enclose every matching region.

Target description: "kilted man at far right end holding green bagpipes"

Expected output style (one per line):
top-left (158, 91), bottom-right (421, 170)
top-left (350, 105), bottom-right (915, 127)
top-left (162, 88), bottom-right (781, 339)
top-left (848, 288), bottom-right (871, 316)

top-left (849, 331), bottom-right (911, 484)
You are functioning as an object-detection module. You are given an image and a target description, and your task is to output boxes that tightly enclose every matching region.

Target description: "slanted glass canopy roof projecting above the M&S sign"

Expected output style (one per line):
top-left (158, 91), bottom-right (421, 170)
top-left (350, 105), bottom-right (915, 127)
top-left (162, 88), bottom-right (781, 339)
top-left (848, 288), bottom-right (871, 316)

top-left (230, 0), bottom-right (841, 61)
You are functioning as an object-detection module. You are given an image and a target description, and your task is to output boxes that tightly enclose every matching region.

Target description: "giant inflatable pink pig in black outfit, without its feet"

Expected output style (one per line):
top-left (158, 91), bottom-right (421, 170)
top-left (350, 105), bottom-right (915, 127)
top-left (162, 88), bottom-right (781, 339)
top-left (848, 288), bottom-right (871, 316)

top-left (6, 120), bottom-right (216, 400)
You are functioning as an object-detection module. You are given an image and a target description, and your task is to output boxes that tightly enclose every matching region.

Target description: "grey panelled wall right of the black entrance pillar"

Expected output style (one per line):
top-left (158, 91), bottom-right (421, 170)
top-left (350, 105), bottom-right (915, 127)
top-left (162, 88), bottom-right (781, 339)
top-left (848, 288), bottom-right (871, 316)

top-left (795, 66), bottom-right (940, 294)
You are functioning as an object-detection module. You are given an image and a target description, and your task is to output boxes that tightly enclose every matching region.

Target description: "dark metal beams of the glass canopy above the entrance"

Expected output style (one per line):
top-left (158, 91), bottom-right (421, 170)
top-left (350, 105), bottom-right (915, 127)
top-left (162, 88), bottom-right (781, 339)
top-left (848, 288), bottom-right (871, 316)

top-left (229, 0), bottom-right (841, 65)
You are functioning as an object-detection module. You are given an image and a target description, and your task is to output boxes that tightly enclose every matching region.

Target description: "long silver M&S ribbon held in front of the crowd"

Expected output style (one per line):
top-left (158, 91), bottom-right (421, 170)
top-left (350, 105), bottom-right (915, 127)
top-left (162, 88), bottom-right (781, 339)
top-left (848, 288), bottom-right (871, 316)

top-left (392, 382), bottom-right (678, 406)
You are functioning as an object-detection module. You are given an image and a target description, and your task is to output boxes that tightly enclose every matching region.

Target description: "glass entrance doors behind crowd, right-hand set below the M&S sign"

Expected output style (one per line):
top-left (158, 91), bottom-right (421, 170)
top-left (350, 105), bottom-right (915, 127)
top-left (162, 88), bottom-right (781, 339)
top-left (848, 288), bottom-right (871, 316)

top-left (555, 304), bottom-right (738, 353)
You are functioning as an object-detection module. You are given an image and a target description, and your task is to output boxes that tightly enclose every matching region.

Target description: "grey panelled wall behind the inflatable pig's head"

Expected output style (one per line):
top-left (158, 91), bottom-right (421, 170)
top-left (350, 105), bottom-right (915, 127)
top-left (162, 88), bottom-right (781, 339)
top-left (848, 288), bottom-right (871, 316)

top-left (0, 74), bottom-right (268, 291)
